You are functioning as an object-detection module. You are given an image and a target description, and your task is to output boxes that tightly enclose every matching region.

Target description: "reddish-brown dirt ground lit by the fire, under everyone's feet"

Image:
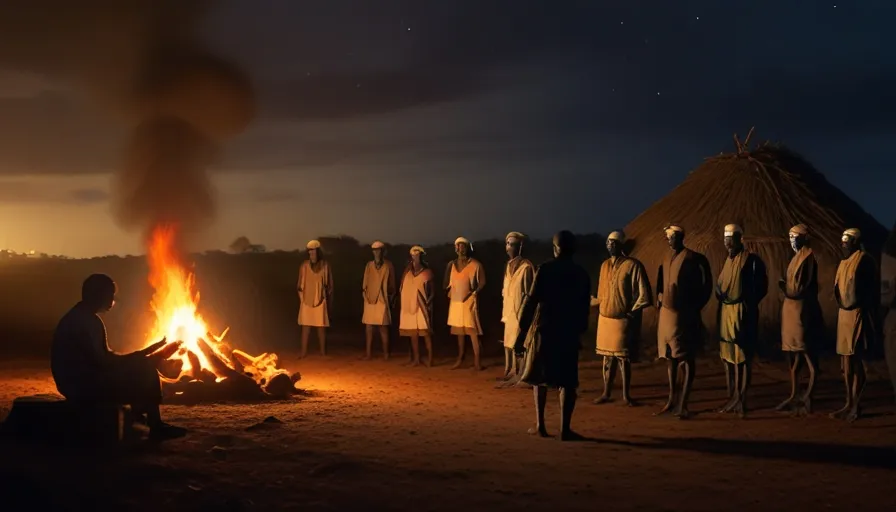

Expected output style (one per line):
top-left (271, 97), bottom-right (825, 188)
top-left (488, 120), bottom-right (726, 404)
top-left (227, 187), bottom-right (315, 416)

top-left (0, 353), bottom-right (896, 512)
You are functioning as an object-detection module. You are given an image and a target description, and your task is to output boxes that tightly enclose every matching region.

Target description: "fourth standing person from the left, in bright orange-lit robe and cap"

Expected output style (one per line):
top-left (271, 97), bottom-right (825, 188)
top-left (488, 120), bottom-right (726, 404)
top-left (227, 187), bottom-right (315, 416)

top-left (445, 237), bottom-right (485, 371)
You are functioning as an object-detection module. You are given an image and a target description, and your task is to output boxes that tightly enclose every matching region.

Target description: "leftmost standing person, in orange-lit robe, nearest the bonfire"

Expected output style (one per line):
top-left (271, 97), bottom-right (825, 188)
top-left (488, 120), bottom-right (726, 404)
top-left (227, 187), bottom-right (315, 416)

top-left (296, 240), bottom-right (333, 359)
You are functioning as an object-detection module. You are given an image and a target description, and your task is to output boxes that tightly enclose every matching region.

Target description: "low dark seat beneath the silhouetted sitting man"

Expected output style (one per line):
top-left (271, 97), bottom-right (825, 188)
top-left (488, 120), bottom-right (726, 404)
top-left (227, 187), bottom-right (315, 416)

top-left (0, 395), bottom-right (133, 445)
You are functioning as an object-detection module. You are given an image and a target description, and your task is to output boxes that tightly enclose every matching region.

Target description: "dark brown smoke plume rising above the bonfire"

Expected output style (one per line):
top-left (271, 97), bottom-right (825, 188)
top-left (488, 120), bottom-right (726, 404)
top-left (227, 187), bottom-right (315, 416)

top-left (0, 0), bottom-right (255, 238)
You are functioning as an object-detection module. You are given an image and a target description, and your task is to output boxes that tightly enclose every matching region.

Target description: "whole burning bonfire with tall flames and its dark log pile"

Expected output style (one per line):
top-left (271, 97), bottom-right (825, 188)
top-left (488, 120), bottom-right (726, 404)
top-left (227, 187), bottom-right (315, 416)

top-left (146, 226), bottom-right (300, 402)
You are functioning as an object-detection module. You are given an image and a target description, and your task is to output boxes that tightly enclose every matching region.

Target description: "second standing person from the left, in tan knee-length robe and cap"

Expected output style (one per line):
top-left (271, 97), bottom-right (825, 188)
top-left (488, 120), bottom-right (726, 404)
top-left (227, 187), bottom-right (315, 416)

top-left (361, 240), bottom-right (395, 361)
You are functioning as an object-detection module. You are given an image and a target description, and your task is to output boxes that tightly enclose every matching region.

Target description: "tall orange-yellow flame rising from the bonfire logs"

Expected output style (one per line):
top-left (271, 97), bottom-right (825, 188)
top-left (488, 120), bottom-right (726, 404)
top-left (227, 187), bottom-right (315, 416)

top-left (147, 225), bottom-right (233, 381)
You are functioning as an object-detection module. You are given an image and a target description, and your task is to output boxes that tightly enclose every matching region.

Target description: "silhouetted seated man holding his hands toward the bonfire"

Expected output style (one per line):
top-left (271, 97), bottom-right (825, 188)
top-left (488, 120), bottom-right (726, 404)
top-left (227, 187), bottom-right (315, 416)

top-left (51, 274), bottom-right (186, 440)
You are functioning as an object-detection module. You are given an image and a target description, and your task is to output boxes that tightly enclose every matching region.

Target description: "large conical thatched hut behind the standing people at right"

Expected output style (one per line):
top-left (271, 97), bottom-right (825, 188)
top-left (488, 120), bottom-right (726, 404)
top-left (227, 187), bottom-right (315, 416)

top-left (625, 132), bottom-right (887, 354)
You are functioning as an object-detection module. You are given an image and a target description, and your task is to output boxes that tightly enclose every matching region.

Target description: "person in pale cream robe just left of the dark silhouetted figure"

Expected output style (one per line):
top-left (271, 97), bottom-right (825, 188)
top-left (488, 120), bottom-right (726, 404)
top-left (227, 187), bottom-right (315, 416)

top-left (498, 231), bottom-right (535, 381)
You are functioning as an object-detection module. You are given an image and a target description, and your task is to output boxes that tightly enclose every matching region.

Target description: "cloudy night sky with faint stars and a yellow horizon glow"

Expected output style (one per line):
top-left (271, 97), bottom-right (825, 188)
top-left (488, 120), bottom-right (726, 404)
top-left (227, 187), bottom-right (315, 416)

top-left (0, 0), bottom-right (896, 256)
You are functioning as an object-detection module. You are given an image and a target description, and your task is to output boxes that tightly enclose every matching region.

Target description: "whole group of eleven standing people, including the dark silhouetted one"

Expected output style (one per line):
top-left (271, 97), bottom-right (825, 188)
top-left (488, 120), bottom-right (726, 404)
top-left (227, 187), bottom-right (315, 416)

top-left (297, 224), bottom-right (877, 438)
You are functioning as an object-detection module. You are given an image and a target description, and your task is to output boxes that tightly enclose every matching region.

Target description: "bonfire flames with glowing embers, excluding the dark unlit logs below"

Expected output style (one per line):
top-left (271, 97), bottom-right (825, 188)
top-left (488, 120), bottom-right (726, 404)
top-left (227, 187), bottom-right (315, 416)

top-left (147, 226), bottom-right (288, 386)
